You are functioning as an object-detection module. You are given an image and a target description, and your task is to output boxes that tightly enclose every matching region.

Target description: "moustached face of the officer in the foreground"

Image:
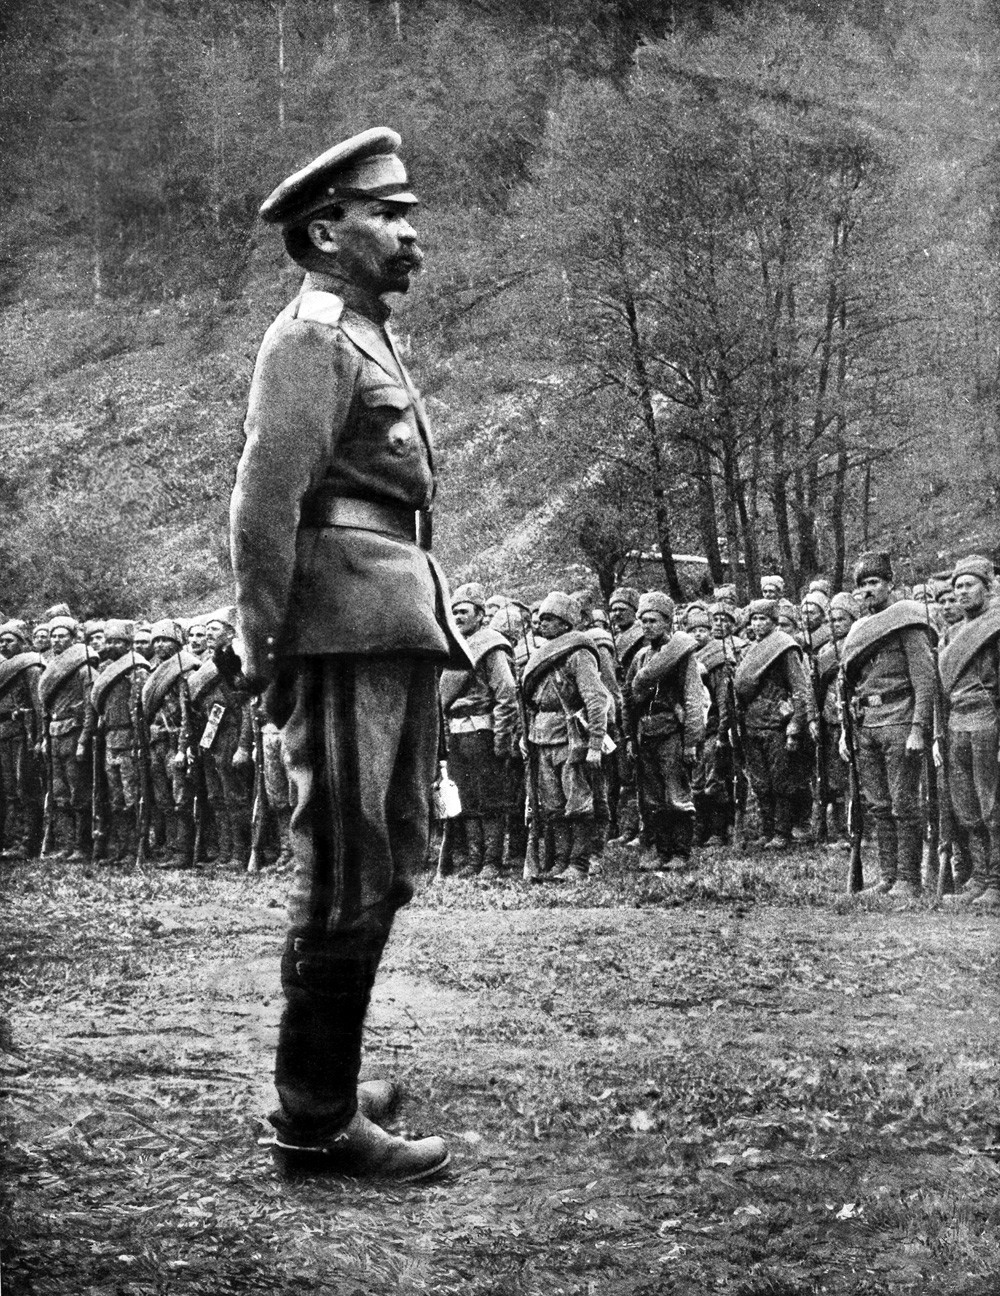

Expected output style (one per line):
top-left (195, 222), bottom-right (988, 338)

top-left (308, 201), bottom-right (424, 297)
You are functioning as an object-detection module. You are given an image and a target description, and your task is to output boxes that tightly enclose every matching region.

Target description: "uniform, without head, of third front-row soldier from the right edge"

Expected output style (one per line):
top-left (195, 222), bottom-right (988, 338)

top-left (733, 630), bottom-right (812, 842)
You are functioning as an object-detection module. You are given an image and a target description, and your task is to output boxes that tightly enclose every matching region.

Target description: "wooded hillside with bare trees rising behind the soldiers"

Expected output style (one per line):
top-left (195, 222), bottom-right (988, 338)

top-left (0, 0), bottom-right (1000, 613)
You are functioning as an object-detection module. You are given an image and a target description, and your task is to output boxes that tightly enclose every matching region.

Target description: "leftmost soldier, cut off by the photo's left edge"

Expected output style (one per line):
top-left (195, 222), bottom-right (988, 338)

top-left (0, 621), bottom-right (45, 859)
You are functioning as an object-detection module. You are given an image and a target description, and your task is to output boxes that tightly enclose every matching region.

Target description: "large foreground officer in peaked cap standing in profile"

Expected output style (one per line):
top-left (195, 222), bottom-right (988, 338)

top-left (231, 127), bottom-right (472, 1181)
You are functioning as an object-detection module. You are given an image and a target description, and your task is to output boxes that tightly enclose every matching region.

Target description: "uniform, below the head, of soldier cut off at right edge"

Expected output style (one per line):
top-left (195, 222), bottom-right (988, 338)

top-left (940, 605), bottom-right (1000, 888)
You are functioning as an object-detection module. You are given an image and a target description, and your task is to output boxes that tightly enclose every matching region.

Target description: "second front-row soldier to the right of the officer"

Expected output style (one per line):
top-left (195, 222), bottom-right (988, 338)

top-left (523, 591), bottom-right (608, 881)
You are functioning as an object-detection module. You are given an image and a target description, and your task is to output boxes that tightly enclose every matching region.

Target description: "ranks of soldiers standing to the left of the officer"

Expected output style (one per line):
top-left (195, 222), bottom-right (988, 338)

top-left (0, 605), bottom-right (290, 870)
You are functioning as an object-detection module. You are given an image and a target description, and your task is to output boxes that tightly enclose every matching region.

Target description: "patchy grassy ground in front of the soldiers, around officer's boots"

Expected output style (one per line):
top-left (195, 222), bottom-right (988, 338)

top-left (0, 850), bottom-right (1000, 1296)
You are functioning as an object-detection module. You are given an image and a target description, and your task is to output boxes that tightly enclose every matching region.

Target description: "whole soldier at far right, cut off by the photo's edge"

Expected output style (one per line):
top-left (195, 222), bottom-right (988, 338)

top-left (940, 553), bottom-right (1000, 908)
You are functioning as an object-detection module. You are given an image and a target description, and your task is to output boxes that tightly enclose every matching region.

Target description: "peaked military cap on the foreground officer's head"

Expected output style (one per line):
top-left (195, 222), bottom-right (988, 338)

top-left (260, 126), bottom-right (418, 226)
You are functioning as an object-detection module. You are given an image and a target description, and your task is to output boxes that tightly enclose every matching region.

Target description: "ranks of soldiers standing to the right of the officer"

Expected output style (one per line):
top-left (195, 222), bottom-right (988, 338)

top-left (438, 553), bottom-right (1000, 907)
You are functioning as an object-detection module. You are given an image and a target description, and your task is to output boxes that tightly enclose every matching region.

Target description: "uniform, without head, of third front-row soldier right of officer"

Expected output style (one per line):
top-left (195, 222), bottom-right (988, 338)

top-left (624, 630), bottom-right (705, 863)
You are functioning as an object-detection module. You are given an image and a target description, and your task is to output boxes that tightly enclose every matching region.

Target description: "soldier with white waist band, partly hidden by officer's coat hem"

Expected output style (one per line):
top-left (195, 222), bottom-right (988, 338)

top-left (440, 583), bottom-right (517, 879)
